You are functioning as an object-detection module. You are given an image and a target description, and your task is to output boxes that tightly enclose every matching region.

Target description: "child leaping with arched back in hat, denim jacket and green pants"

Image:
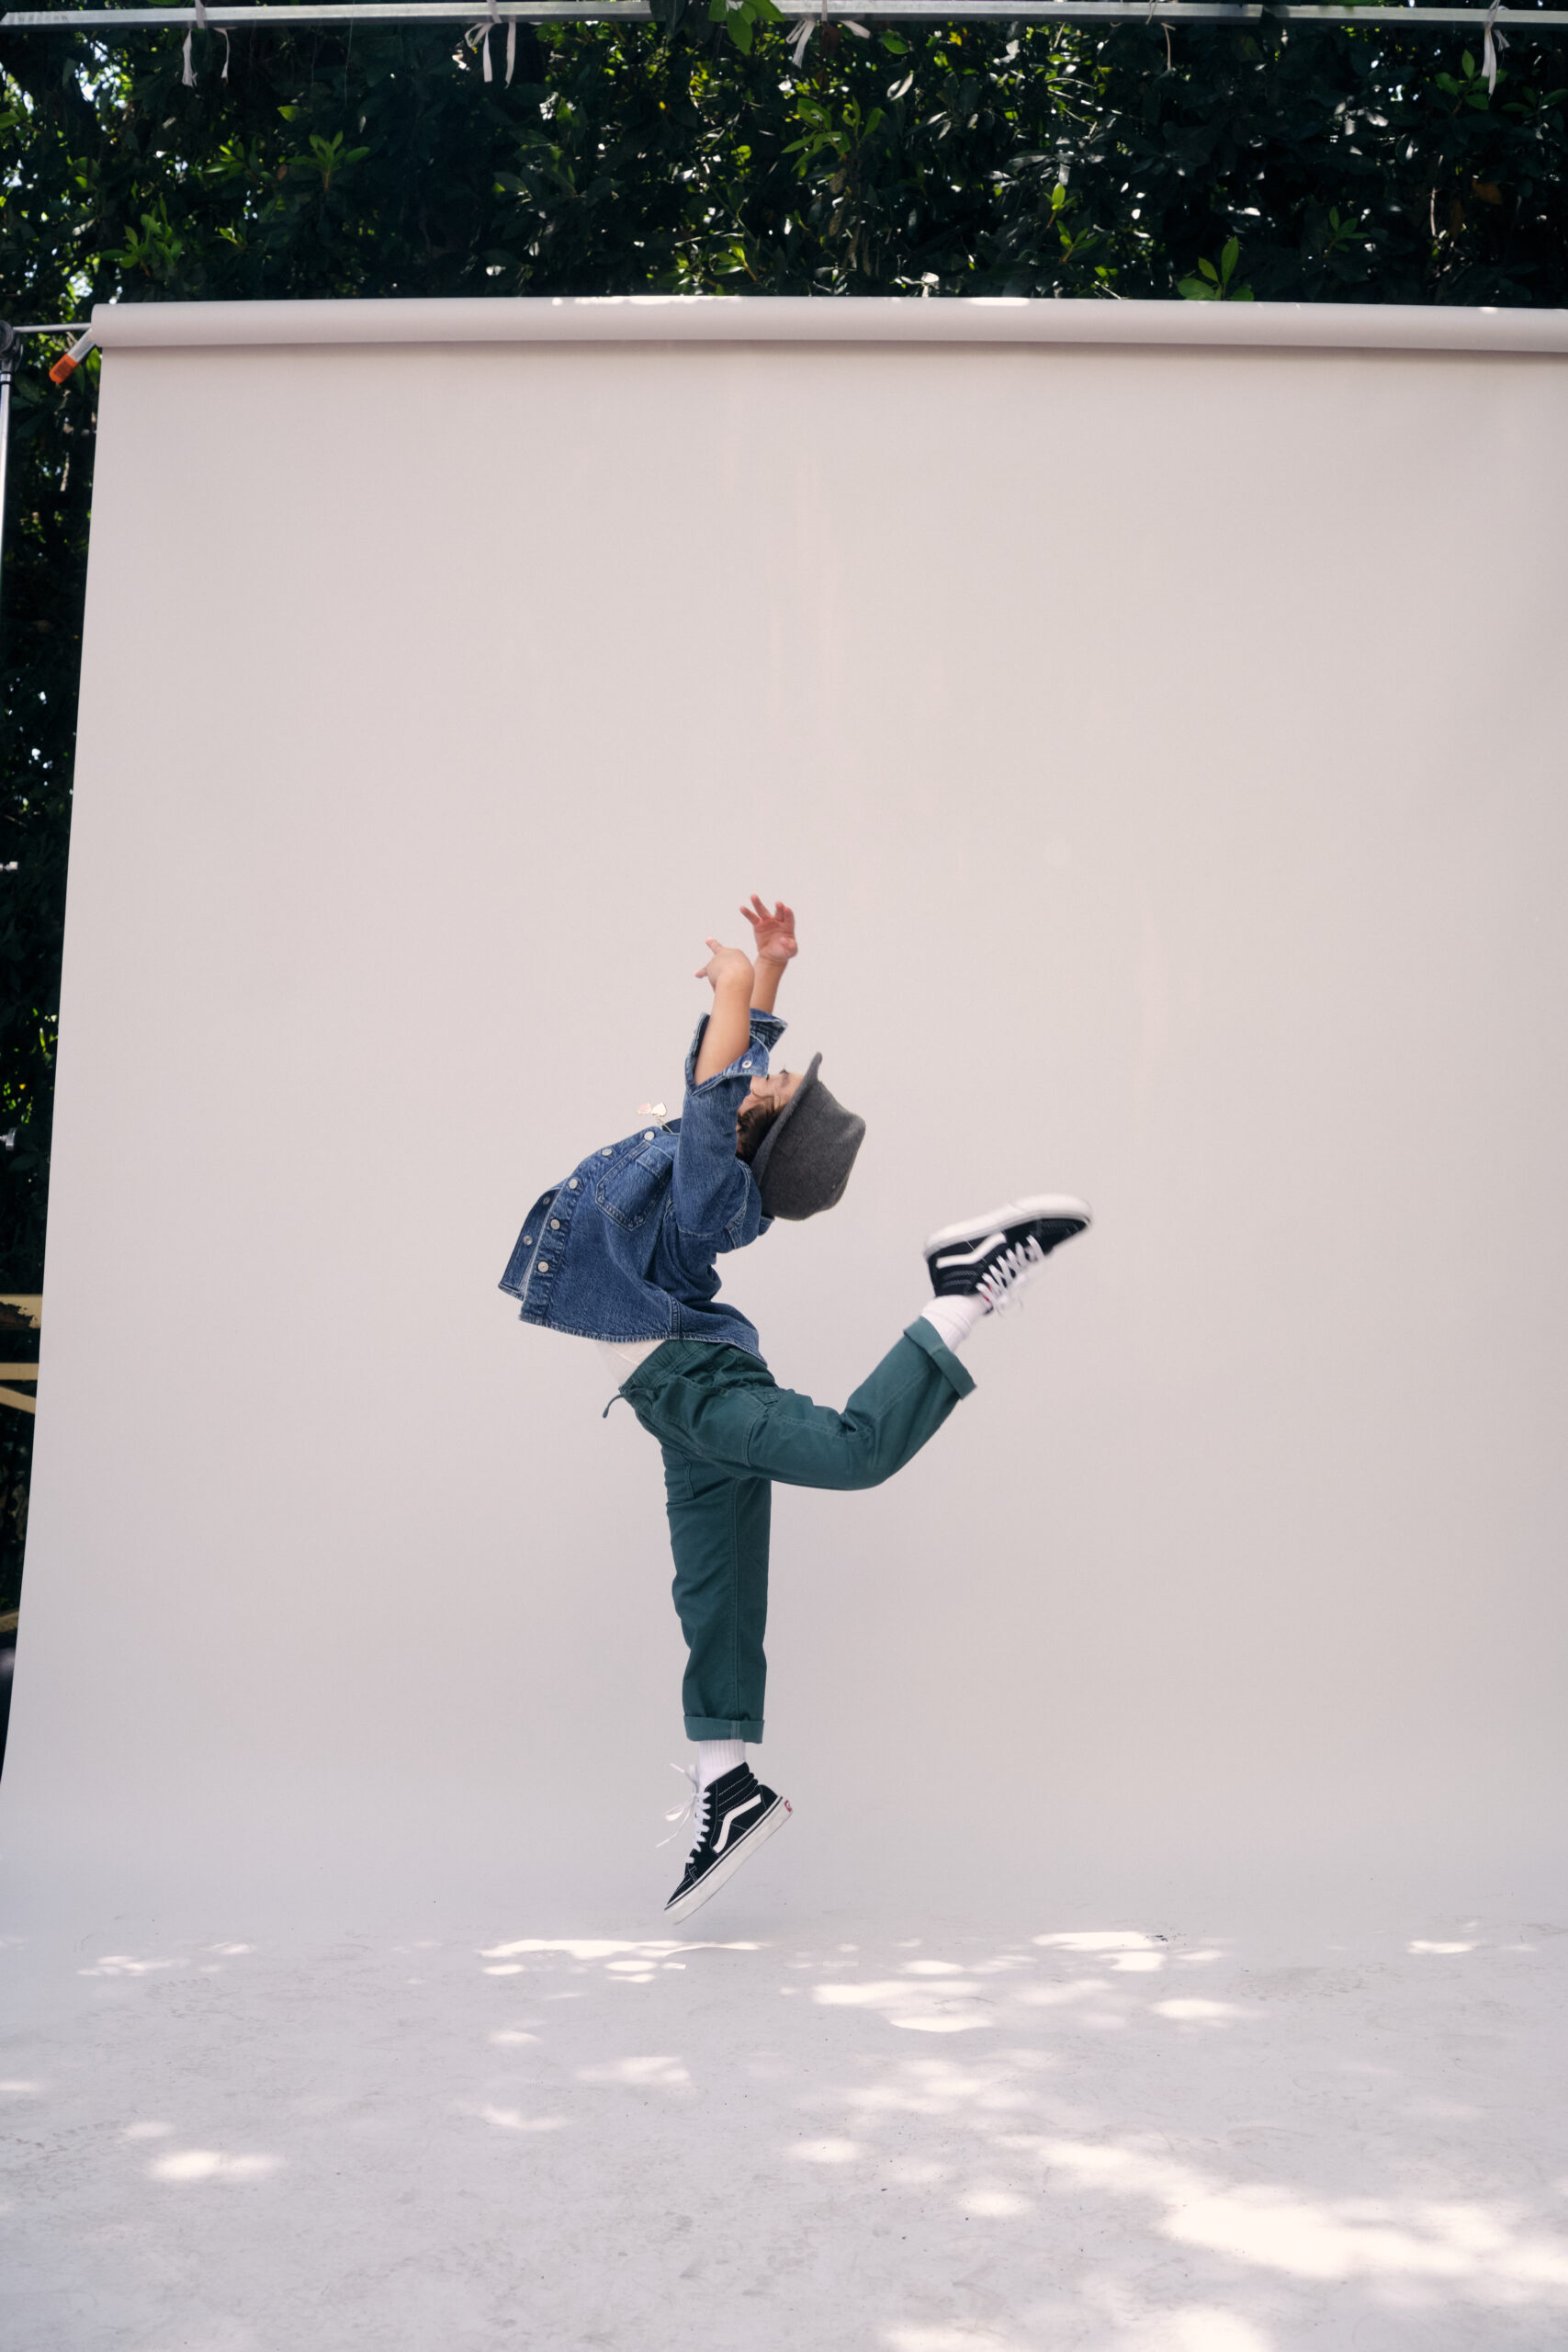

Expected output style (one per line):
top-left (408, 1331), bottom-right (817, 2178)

top-left (501, 896), bottom-right (1089, 1919)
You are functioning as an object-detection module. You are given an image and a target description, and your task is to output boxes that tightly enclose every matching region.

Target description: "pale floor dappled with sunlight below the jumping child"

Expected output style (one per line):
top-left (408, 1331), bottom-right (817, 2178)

top-left (0, 1891), bottom-right (1568, 2352)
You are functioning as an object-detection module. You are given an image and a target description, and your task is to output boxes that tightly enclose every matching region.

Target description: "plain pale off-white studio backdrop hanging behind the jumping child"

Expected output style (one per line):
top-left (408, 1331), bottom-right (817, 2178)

top-left (0, 303), bottom-right (1568, 1907)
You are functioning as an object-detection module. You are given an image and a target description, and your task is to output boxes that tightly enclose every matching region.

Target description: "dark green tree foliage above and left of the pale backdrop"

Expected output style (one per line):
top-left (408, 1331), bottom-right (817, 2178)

top-left (0, 0), bottom-right (1568, 1289)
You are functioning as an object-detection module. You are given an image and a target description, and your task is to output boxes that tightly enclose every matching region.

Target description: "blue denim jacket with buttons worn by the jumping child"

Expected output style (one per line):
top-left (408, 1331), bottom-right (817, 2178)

top-left (501, 1012), bottom-right (785, 1355)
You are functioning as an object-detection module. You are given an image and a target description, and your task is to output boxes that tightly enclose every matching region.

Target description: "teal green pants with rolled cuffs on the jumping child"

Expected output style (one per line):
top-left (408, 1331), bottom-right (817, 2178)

top-left (621, 1319), bottom-right (976, 1740)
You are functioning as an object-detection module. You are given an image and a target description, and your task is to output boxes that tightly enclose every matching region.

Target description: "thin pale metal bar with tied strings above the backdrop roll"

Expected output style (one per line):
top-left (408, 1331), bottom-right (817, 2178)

top-left (0, 0), bottom-right (1568, 35)
